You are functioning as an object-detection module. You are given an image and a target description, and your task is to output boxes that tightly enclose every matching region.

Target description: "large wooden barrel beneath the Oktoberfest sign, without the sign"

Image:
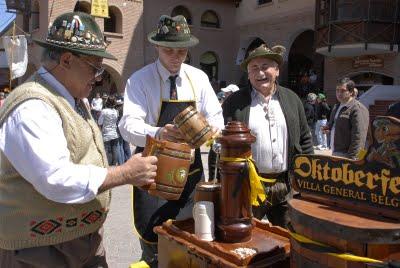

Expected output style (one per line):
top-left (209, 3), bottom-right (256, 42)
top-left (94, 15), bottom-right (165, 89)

top-left (289, 199), bottom-right (400, 268)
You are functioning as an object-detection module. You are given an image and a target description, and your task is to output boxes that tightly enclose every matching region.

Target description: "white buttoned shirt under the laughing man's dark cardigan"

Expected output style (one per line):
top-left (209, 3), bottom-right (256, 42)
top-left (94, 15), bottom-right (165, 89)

top-left (249, 89), bottom-right (288, 173)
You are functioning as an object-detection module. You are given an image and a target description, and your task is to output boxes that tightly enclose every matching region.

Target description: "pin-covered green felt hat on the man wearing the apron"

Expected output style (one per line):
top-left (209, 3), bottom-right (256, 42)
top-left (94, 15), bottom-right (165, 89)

top-left (147, 15), bottom-right (199, 48)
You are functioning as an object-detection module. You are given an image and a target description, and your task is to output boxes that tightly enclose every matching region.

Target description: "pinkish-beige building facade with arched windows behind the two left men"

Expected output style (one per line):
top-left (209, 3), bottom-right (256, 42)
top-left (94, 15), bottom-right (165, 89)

top-left (18, 0), bottom-right (238, 96)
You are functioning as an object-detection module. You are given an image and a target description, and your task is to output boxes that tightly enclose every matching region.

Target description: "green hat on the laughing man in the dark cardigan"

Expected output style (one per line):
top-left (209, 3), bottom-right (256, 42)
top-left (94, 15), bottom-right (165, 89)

top-left (240, 44), bottom-right (286, 71)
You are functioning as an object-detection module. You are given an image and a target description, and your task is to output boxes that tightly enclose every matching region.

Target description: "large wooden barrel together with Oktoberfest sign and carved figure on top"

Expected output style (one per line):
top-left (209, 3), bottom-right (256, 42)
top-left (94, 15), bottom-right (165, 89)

top-left (289, 117), bottom-right (400, 268)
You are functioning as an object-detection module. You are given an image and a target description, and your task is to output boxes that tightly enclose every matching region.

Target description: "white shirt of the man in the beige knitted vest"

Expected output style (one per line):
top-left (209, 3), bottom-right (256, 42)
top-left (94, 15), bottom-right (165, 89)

top-left (0, 67), bottom-right (107, 203)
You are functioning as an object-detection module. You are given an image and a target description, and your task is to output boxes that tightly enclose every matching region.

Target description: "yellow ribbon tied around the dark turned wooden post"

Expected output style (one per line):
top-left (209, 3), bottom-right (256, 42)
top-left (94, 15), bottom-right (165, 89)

top-left (220, 156), bottom-right (276, 207)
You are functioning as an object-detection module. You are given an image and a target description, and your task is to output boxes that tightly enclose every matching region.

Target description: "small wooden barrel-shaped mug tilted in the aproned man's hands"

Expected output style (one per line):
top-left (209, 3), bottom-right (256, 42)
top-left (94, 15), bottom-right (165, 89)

top-left (174, 106), bottom-right (213, 148)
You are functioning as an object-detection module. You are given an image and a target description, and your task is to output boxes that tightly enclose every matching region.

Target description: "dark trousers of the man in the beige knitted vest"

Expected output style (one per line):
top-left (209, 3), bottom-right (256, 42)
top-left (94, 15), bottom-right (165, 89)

top-left (0, 229), bottom-right (108, 268)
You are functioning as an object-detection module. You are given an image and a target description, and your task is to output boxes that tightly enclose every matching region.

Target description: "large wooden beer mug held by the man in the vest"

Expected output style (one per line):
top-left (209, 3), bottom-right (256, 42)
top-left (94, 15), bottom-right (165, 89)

top-left (143, 135), bottom-right (191, 200)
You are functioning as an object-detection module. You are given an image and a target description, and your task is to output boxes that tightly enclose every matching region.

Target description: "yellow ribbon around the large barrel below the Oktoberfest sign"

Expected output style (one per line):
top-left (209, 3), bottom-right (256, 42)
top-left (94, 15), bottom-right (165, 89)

top-left (289, 230), bottom-right (384, 263)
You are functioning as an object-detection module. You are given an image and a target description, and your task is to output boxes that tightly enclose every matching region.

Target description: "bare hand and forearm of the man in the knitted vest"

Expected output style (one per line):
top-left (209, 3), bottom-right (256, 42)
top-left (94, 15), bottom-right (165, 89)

top-left (99, 154), bottom-right (158, 193)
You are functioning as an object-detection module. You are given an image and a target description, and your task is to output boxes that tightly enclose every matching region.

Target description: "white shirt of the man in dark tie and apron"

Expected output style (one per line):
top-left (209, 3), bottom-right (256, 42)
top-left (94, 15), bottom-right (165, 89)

top-left (119, 60), bottom-right (224, 146)
